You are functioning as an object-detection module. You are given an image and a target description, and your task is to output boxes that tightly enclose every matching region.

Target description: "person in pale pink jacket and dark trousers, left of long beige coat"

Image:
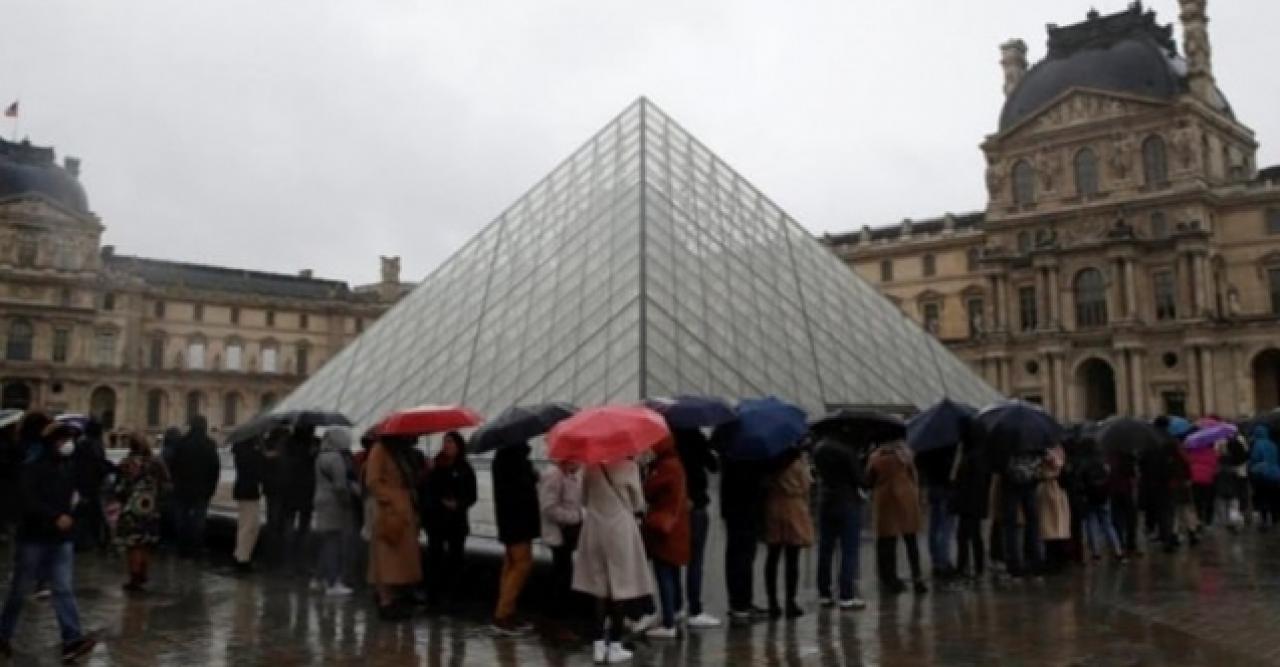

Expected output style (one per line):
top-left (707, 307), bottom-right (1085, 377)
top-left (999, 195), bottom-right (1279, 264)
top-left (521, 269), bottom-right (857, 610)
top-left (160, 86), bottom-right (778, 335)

top-left (538, 461), bottom-right (584, 639)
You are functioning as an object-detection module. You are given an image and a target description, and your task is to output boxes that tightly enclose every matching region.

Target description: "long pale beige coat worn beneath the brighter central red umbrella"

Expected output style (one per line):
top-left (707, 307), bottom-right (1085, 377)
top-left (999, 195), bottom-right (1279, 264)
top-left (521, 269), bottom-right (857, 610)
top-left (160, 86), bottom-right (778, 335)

top-left (573, 461), bottom-right (654, 600)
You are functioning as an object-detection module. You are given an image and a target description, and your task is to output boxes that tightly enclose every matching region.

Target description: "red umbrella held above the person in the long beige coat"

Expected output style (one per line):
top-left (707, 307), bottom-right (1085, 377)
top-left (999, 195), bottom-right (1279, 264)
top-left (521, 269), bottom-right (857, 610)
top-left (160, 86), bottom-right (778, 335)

top-left (547, 406), bottom-right (671, 463)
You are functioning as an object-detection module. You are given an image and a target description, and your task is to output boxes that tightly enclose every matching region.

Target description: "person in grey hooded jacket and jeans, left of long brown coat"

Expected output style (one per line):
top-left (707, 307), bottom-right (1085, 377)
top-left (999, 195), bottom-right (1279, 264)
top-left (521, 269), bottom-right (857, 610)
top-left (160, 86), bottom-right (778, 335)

top-left (312, 426), bottom-right (360, 597)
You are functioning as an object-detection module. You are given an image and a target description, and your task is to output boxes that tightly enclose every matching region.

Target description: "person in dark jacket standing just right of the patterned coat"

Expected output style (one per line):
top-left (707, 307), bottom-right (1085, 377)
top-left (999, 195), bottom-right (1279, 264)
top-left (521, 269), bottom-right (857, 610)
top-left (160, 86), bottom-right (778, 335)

top-left (170, 415), bottom-right (223, 558)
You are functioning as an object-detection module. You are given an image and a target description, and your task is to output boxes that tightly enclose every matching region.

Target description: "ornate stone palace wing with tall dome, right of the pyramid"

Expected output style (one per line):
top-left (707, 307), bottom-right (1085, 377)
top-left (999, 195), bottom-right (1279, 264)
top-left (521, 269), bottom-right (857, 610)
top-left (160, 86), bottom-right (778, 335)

top-left (824, 0), bottom-right (1280, 420)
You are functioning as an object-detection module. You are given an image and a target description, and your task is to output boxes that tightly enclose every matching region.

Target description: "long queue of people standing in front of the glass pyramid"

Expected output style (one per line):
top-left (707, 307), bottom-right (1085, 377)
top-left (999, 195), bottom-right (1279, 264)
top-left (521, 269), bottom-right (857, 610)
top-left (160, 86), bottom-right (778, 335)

top-left (0, 401), bottom-right (1280, 663)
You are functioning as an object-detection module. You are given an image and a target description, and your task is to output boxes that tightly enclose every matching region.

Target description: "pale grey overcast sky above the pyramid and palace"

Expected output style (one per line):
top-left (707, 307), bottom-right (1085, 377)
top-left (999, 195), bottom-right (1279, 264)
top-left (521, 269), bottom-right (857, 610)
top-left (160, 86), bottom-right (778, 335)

top-left (0, 0), bottom-right (1280, 282)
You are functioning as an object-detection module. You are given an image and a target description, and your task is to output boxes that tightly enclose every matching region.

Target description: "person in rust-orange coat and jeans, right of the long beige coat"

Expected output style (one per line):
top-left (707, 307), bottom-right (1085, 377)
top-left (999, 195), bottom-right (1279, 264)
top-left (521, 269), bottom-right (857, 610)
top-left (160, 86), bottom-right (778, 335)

top-left (641, 438), bottom-right (691, 639)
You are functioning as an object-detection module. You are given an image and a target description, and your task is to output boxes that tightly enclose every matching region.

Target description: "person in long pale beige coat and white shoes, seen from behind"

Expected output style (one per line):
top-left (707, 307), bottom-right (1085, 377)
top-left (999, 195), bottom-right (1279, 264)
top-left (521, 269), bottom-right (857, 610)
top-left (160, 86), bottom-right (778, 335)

top-left (573, 460), bottom-right (653, 664)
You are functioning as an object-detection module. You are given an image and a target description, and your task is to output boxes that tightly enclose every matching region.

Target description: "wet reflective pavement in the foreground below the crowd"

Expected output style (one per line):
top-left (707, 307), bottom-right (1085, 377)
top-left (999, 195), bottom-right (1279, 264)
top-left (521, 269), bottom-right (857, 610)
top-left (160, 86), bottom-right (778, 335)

top-left (0, 534), bottom-right (1280, 667)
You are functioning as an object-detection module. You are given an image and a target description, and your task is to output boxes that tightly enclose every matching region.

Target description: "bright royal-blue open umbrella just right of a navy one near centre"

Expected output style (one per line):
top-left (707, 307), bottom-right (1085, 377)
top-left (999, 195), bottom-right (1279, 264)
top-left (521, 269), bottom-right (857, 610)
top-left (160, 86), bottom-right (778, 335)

top-left (712, 396), bottom-right (809, 461)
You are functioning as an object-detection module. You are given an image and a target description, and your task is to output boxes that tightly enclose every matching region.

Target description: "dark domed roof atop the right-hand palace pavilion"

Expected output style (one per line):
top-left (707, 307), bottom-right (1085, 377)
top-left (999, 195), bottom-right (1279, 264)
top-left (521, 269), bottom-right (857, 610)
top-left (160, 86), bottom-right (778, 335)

top-left (1000, 4), bottom-right (1231, 131)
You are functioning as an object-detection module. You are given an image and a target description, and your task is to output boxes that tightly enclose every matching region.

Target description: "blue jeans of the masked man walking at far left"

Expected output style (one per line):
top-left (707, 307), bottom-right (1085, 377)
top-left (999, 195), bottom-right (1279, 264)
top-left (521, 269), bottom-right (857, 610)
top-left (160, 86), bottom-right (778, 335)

top-left (0, 542), bottom-right (84, 644)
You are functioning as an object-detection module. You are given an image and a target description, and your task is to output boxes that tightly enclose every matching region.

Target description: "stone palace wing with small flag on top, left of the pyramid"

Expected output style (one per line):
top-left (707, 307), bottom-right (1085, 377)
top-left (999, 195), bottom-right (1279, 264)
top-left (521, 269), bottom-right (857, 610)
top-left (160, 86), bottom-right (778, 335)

top-left (0, 140), bottom-right (410, 431)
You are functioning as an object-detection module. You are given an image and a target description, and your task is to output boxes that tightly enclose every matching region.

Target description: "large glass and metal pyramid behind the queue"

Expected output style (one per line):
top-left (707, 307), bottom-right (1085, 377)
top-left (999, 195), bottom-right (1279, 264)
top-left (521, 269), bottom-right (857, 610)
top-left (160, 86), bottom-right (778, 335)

top-left (278, 97), bottom-right (998, 425)
